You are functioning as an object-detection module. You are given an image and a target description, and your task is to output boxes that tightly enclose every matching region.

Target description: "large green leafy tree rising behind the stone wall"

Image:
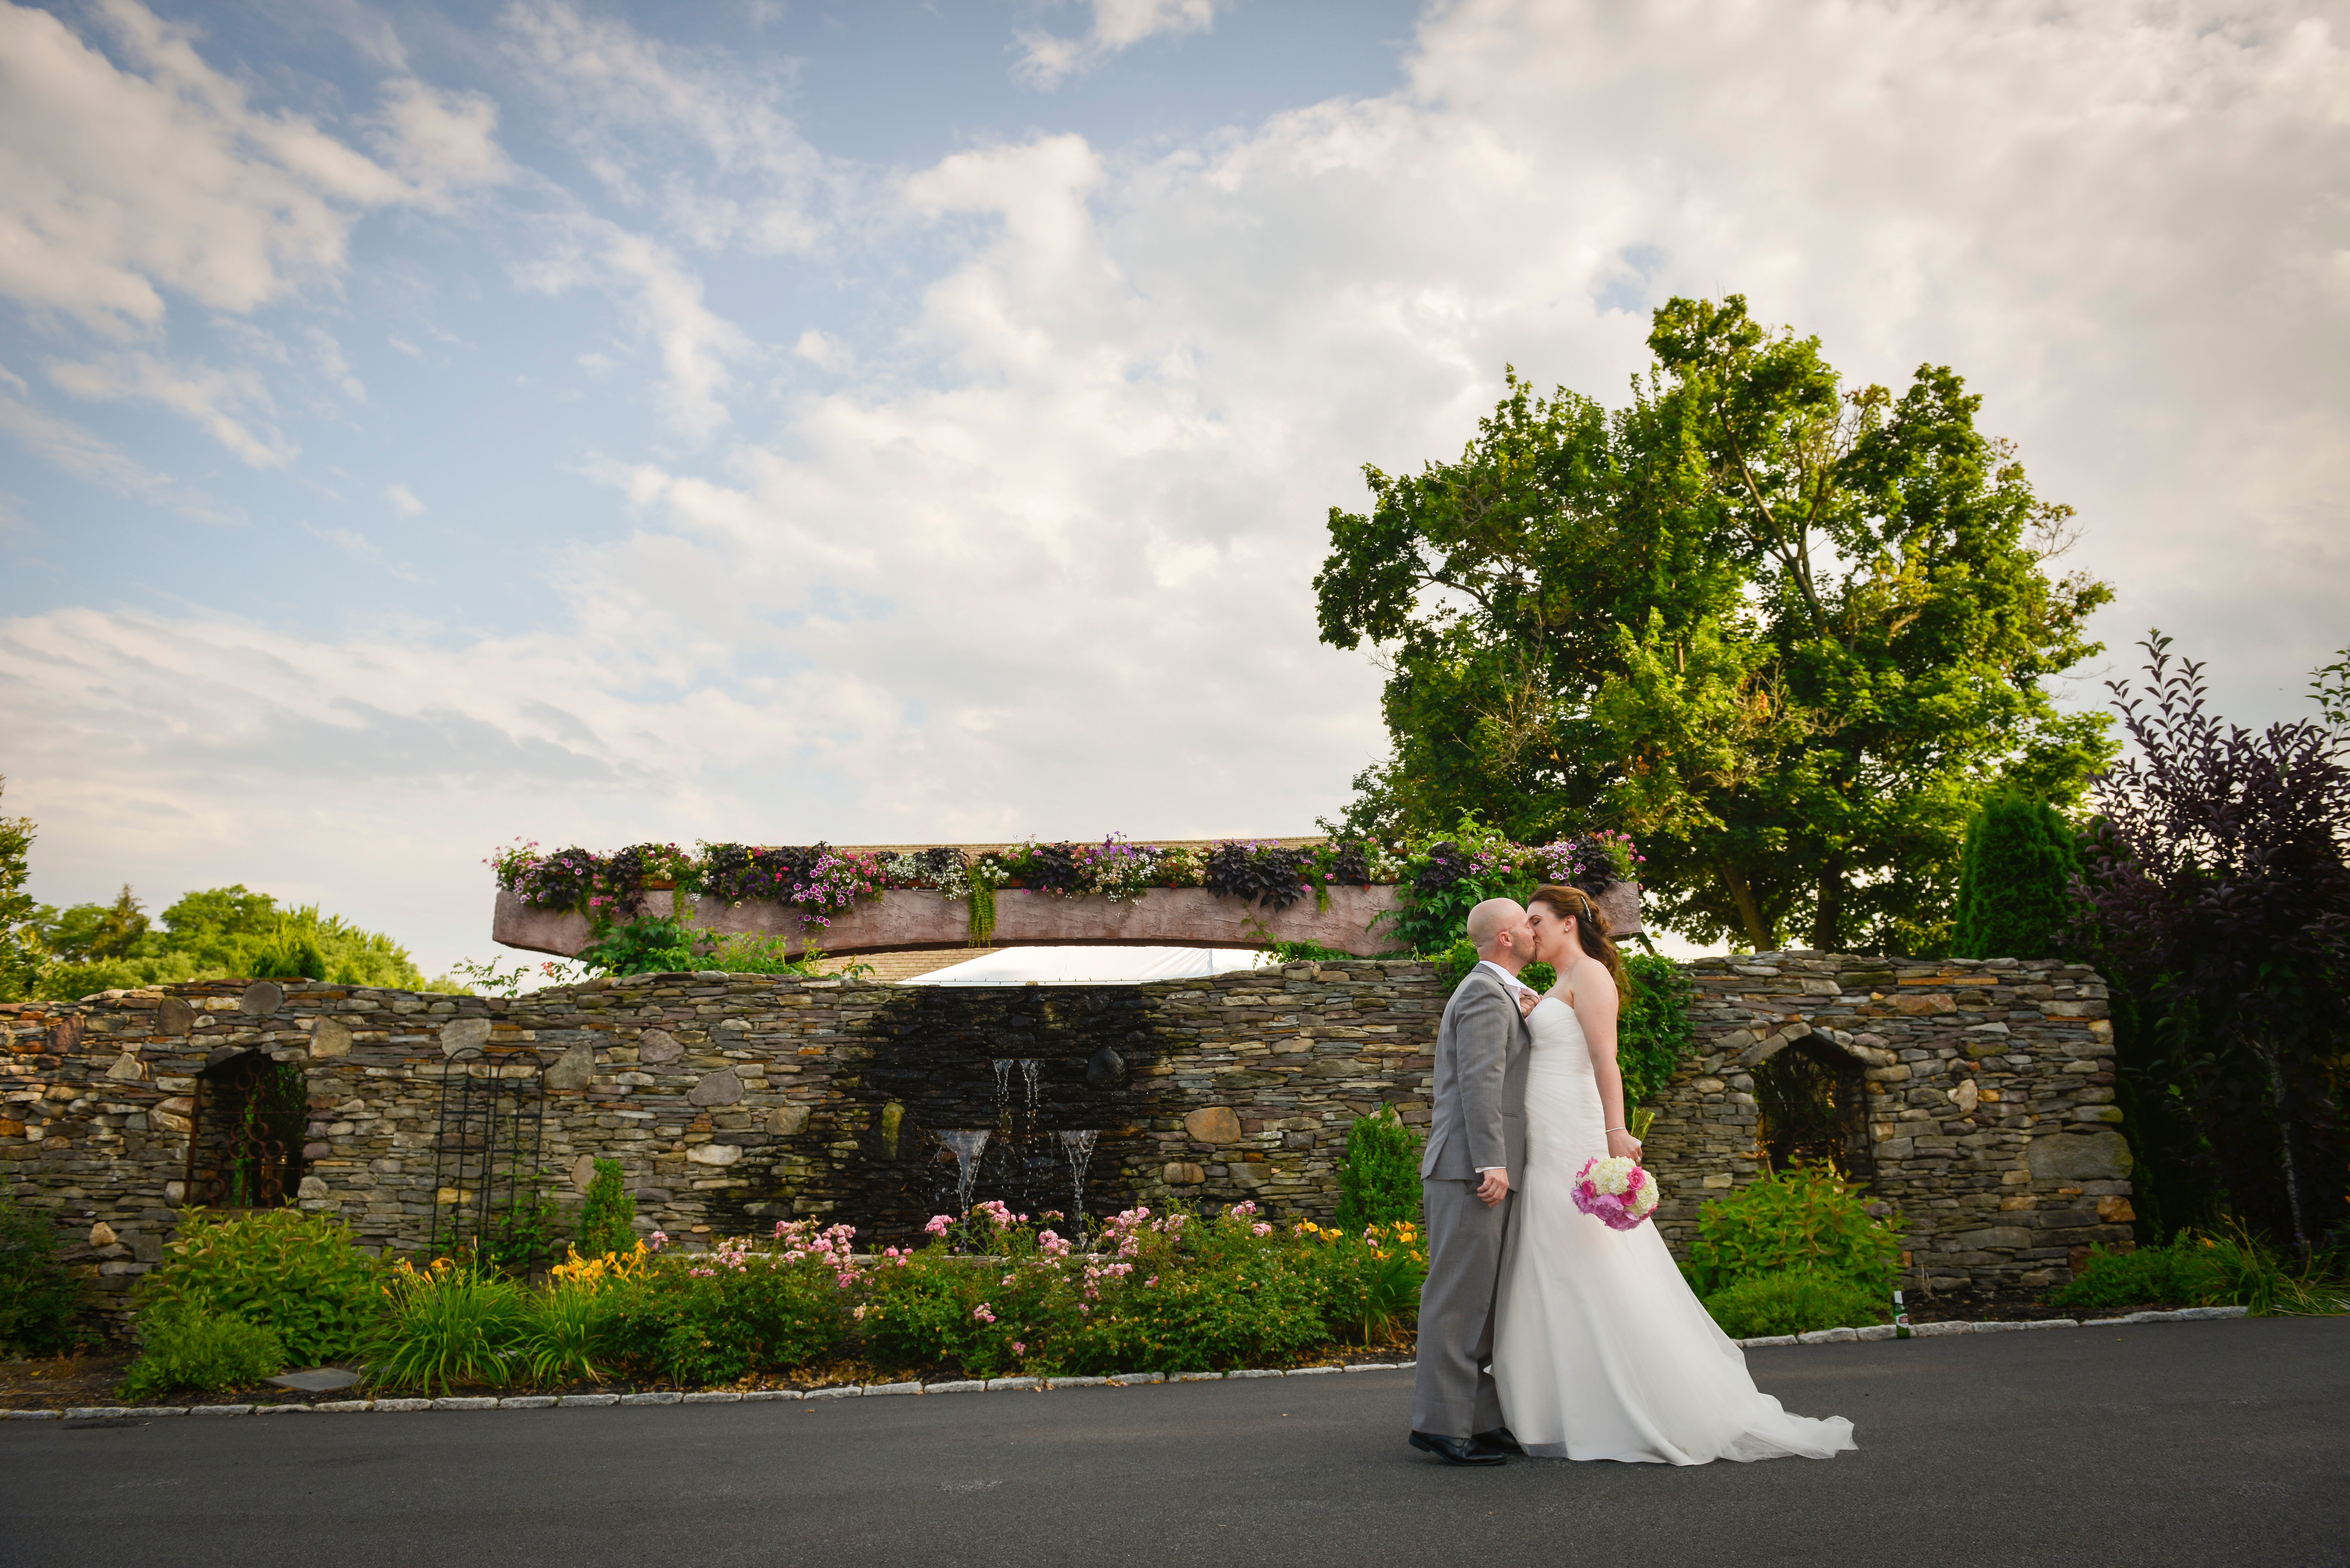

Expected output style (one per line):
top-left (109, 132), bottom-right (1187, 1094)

top-left (1314, 296), bottom-right (2113, 952)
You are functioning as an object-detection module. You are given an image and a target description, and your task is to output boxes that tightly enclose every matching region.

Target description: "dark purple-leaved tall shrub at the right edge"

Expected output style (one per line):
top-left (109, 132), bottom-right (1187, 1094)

top-left (2084, 632), bottom-right (2350, 1251)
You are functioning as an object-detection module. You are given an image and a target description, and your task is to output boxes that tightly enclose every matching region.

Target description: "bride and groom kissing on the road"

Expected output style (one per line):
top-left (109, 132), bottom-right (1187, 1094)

top-left (1412, 886), bottom-right (1854, 1465)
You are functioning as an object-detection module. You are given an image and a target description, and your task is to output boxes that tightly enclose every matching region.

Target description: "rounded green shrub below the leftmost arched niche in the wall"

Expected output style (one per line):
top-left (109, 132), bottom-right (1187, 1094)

top-left (139, 1208), bottom-right (378, 1366)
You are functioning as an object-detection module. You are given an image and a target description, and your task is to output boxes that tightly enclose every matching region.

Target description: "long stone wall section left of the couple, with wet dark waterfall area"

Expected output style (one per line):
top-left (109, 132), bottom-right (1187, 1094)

top-left (0, 961), bottom-right (1445, 1316)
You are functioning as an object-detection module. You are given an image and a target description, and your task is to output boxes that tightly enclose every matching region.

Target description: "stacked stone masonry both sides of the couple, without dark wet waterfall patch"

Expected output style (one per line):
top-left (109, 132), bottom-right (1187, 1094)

top-left (0, 954), bottom-right (2129, 1293)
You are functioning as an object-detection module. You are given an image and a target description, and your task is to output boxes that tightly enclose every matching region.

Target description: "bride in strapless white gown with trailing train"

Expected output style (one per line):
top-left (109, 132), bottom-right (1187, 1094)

top-left (1492, 886), bottom-right (1854, 1465)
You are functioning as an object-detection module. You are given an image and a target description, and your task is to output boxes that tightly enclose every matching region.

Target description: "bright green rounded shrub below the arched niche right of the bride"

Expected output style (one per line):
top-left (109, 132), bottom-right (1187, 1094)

top-left (1685, 1164), bottom-right (1908, 1298)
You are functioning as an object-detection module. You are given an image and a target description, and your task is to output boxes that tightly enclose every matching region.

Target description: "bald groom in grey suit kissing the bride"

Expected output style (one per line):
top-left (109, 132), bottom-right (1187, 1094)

top-left (1412, 898), bottom-right (1535, 1465)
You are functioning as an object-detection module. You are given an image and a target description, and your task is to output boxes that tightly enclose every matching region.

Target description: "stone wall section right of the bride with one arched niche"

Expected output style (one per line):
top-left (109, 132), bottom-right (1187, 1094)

top-left (1647, 952), bottom-right (2132, 1291)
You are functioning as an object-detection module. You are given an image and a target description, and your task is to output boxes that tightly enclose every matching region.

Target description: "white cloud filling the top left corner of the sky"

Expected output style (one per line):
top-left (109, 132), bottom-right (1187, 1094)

top-left (0, 0), bottom-right (501, 331)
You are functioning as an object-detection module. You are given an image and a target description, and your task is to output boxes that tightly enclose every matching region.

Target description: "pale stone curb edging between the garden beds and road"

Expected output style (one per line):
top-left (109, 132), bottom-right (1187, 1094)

top-left (0, 1307), bottom-right (2251, 1420)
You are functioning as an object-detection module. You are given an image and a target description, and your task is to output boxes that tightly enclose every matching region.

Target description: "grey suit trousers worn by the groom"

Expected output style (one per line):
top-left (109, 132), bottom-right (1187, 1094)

top-left (1412, 1171), bottom-right (1518, 1436)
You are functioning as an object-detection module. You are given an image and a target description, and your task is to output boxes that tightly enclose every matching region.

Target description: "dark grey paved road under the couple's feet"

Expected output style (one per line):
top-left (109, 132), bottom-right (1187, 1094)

top-left (0, 1319), bottom-right (2350, 1568)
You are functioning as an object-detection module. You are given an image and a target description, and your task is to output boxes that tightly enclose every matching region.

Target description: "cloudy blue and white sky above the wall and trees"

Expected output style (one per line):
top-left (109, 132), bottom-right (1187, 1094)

top-left (0, 0), bottom-right (2350, 973)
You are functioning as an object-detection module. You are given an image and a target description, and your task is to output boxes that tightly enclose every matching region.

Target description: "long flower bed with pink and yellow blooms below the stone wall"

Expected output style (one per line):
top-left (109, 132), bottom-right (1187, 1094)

top-left (114, 1204), bottom-right (1427, 1394)
